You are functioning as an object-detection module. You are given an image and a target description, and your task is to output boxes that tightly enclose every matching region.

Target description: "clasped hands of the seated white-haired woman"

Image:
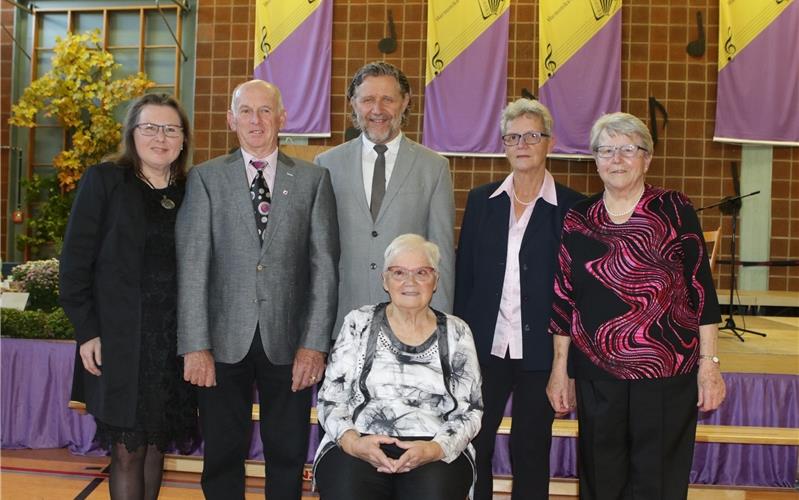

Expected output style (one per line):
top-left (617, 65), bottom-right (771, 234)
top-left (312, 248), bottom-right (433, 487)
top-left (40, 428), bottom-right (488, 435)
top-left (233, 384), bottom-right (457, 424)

top-left (339, 430), bottom-right (444, 474)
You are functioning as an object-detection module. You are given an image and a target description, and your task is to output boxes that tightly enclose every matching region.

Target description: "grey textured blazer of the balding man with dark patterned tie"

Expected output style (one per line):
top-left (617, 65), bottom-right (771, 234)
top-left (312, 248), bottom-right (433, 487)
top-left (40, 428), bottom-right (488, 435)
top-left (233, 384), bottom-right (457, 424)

top-left (175, 151), bottom-right (339, 364)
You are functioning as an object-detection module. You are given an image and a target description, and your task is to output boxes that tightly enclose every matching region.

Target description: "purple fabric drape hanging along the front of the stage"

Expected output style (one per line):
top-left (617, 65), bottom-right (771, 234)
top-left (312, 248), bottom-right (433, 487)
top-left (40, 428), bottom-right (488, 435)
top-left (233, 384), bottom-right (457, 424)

top-left (0, 338), bottom-right (799, 488)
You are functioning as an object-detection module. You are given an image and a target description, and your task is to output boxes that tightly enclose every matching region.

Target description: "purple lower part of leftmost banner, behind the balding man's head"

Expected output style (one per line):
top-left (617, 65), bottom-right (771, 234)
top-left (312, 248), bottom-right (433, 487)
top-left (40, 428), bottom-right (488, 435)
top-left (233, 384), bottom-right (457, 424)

top-left (253, 0), bottom-right (333, 136)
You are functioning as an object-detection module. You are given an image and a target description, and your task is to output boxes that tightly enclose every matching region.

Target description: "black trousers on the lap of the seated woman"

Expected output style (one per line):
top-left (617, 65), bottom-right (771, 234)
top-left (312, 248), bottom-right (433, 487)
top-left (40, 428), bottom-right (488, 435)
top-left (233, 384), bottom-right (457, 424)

top-left (316, 446), bottom-right (472, 500)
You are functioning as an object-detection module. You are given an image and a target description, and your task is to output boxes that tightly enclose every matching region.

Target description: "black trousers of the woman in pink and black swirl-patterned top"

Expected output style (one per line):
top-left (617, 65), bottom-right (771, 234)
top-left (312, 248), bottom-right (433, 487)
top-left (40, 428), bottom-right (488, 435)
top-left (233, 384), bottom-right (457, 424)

top-left (576, 374), bottom-right (697, 500)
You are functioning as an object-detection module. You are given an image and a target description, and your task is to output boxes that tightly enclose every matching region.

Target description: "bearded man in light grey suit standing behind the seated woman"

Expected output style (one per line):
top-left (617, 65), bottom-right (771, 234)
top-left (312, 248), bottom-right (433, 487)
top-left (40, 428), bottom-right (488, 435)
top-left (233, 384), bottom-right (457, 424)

top-left (314, 62), bottom-right (455, 336)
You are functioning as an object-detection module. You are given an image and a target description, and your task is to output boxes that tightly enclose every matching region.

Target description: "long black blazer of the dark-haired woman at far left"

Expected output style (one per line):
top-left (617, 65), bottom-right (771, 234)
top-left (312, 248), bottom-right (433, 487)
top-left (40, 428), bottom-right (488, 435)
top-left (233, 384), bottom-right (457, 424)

top-left (59, 163), bottom-right (160, 427)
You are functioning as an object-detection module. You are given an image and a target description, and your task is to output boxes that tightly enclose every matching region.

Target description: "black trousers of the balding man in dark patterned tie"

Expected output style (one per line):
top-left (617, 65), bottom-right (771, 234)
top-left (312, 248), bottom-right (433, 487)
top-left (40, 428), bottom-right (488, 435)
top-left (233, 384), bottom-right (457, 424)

top-left (198, 329), bottom-right (311, 500)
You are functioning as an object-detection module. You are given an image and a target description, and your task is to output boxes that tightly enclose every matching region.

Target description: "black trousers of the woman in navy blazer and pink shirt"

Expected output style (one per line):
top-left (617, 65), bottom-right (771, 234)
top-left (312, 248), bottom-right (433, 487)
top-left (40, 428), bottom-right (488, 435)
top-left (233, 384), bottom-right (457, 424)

top-left (472, 356), bottom-right (555, 500)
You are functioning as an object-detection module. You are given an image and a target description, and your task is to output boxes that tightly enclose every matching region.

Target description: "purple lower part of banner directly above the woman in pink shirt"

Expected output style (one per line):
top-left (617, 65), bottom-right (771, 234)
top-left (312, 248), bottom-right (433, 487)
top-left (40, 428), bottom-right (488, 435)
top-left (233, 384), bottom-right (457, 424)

top-left (538, 10), bottom-right (621, 155)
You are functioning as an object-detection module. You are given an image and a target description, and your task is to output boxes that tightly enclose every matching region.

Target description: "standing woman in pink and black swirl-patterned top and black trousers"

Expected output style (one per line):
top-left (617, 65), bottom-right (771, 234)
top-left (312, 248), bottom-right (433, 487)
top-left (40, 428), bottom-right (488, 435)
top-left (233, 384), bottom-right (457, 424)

top-left (547, 113), bottom-right (725, 499)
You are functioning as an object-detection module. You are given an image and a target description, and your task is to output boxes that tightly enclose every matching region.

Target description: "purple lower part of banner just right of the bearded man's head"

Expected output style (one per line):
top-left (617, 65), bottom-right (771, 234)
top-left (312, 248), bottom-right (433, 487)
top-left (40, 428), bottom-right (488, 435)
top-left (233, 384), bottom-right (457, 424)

top-left (422, 10), bottom-right (510, 154)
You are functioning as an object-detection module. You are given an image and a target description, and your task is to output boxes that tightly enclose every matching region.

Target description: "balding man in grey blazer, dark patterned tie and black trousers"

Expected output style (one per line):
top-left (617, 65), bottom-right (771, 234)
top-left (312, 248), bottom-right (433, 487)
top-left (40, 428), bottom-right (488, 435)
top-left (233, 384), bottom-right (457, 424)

top-left (176, 80), bottom-right (339, 500)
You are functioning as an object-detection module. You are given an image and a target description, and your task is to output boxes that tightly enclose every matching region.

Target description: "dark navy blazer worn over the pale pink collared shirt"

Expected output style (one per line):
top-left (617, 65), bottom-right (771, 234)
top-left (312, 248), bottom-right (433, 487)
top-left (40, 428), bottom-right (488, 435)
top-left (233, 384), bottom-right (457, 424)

top-left (455, 182), bottom-right (584, 371)
